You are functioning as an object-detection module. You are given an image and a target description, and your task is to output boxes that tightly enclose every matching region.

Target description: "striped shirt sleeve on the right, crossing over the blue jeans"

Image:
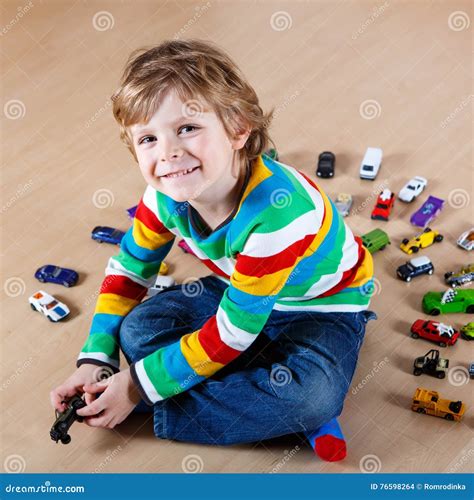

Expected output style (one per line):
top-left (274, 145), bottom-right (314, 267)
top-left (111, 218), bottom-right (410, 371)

top-left (130, 207), bottom-right (321, 404)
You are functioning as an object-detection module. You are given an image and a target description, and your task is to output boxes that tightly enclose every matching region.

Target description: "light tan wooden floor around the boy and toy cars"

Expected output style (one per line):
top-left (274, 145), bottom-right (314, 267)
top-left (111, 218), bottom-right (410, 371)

top-left (0, 0), bottom-right (474, 473)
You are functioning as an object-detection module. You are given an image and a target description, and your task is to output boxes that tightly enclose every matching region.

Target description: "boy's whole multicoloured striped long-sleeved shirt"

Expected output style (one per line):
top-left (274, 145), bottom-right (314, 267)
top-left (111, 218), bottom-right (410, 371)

top-left (77, 156), bottom-right (373, 404)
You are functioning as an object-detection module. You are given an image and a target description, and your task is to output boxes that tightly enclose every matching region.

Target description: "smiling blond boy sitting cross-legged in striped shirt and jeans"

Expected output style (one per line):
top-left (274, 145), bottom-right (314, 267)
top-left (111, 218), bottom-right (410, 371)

top-left (51, 40), bottom-right (375, 460)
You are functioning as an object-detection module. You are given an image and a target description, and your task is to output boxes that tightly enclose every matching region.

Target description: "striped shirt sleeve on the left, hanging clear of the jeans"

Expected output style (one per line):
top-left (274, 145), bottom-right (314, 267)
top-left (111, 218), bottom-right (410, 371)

top-left (76, 187), bottom-right (175, 372)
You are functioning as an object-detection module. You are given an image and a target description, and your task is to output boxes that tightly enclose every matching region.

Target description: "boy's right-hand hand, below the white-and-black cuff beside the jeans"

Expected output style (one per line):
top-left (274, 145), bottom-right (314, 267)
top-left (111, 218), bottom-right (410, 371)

top-left (76, 369), bottom-right (141, 429)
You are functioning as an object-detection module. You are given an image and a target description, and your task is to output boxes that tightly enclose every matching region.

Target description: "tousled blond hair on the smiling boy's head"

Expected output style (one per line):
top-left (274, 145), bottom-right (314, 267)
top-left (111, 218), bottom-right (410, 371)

top-left (112, 39), bottom-right (274, 167)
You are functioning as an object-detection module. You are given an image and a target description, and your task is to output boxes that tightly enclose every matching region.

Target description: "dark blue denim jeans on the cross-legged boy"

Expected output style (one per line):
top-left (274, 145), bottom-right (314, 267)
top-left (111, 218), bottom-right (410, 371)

top-left (120, 276), bottom-right (376, 445)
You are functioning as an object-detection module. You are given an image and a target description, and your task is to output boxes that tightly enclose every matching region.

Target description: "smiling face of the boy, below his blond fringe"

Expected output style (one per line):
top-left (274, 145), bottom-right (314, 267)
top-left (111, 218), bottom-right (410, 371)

top-left (130, 92), bottom-right (249, 203)
